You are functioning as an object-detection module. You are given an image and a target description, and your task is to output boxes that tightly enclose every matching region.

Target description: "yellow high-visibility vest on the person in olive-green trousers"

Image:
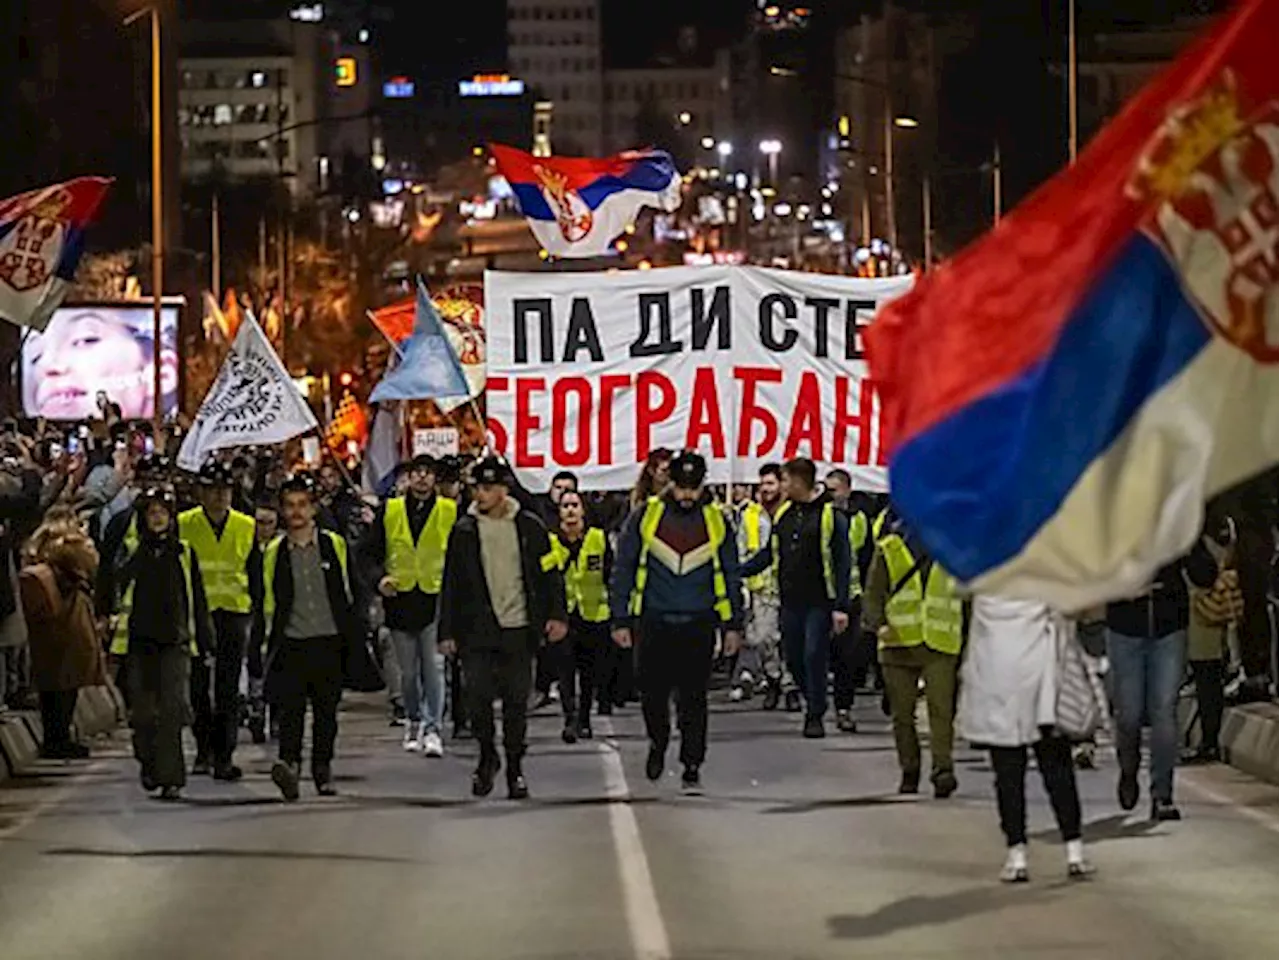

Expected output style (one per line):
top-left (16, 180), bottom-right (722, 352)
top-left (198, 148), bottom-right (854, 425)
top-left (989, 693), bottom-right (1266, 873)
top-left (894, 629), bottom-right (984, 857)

top-left (879, 534), bottom-right (964, 655)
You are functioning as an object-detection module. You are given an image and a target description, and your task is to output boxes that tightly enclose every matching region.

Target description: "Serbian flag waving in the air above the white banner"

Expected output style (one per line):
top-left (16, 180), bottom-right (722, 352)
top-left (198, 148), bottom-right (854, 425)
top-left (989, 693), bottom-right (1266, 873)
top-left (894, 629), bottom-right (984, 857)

top-left (489, 143), bottom-right (681, 257)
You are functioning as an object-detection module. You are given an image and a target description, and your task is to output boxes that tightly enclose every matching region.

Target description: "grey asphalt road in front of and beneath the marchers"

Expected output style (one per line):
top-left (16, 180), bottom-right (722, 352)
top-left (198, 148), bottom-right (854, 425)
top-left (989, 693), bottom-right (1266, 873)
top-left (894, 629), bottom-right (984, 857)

top-left (0, 686), bottom-right (1280, 960)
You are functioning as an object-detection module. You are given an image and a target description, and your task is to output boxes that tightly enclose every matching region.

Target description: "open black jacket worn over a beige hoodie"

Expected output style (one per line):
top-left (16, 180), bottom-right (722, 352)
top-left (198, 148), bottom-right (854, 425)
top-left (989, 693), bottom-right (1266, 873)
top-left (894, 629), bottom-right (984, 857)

top-left (439, 499), bottom-right (568, 648)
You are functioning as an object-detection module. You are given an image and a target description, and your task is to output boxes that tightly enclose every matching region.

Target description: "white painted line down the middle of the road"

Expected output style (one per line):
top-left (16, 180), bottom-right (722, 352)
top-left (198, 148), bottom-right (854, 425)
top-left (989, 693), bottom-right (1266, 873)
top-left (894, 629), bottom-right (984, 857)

top-left (596, 717), bottom-right (671, 960)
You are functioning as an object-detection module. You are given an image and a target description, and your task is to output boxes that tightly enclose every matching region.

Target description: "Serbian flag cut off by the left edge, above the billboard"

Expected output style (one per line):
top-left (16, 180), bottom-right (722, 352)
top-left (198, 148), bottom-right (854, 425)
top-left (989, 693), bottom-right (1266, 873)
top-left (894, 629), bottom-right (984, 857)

top-left (0, 177), bottom-right (111, 330)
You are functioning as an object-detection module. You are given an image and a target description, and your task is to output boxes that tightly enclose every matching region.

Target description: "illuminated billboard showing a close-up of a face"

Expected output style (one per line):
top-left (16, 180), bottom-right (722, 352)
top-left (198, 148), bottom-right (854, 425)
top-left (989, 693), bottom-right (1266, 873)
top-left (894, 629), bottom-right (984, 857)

top-left (22, 300), bottom-right (182, 420)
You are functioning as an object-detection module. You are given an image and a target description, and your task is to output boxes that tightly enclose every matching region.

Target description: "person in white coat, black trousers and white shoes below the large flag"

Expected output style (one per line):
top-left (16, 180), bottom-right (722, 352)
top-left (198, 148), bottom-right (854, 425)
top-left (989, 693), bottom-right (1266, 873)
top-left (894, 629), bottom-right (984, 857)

top-left (956, 595), bottom-right (1092, 883)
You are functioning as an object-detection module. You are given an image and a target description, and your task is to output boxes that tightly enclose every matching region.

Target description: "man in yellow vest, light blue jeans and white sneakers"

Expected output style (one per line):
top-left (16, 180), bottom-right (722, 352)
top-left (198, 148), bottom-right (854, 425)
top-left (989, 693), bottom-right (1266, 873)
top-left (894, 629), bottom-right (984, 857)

top-left (361, 454), bottom-right (458, 756)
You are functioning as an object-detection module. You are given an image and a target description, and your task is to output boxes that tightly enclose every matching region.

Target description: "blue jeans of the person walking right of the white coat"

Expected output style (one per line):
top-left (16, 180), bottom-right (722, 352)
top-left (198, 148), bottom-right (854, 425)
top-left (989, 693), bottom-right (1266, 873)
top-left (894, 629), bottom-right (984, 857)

top-left (1107, 630), bottom-right (1187, 801)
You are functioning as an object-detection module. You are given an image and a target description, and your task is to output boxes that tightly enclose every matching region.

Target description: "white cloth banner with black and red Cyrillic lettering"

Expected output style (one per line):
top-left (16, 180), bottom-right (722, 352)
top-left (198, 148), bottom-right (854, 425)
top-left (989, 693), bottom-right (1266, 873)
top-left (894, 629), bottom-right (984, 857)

top-left (485, 266), bottom-right (911, 492)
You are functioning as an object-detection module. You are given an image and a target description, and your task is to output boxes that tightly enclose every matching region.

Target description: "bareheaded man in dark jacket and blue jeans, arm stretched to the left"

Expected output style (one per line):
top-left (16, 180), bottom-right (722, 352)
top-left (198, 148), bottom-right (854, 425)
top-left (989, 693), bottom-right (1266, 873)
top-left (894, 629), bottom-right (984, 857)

top-left (742, 458), bottom-right (850, 739)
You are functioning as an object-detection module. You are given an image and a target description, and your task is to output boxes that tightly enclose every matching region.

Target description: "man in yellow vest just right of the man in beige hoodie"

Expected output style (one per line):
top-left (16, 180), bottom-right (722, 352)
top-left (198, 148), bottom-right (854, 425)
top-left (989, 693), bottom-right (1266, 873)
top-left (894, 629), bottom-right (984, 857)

top-left (549, 490), bottom-right (613, 744)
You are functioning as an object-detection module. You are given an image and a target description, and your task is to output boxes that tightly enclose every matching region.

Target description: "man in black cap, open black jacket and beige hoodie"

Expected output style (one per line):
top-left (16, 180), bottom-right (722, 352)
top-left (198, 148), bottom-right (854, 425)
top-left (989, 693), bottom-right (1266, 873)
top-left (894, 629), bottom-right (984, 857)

top-left (440, 457), bottom-right (568, 800)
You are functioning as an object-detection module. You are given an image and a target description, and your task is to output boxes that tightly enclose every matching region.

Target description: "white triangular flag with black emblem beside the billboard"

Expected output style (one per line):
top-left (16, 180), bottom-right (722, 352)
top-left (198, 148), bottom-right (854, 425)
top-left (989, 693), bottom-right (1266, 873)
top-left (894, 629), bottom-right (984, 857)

top-left (178, 316), bottom-right (320, 471)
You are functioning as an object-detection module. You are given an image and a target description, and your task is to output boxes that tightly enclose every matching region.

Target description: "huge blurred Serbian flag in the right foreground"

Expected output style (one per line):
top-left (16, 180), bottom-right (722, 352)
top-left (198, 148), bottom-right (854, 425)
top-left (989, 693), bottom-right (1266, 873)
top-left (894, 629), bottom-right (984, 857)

top-left (867, 0), bottom-right (1280, 611)
